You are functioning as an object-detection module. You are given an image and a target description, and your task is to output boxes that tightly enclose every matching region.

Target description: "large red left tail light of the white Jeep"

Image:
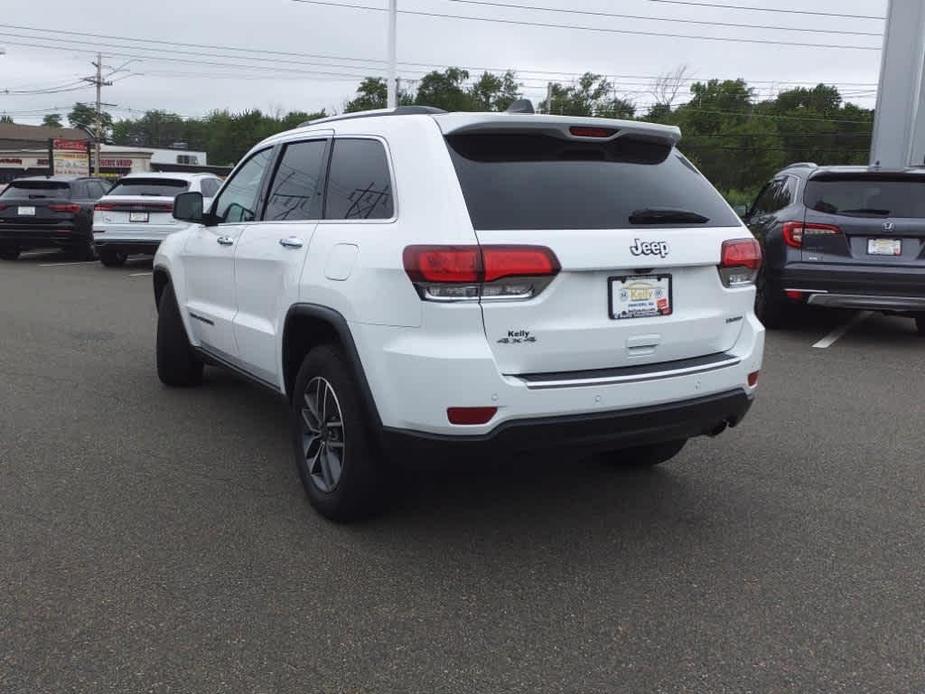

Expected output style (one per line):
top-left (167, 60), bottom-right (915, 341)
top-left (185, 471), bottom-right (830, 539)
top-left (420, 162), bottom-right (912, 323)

top-left (403, 246), bottom-right (561, 301)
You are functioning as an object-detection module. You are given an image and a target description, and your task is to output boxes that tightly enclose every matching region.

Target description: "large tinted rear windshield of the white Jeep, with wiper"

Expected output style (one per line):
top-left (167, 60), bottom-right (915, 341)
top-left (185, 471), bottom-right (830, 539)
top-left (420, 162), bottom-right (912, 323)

top-left (447, 134), bottom-right (741, 230)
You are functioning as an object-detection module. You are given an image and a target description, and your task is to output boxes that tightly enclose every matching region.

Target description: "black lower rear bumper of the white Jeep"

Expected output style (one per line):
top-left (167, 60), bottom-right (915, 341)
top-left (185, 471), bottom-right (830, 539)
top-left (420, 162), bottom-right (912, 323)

top-left (383, 389), bottom-right (753, 454)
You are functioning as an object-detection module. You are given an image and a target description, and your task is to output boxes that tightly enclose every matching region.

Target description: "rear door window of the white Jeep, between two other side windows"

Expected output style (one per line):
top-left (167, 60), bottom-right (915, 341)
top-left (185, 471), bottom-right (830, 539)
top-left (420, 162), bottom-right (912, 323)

top-left (263, 140), bottom-right (328, 222)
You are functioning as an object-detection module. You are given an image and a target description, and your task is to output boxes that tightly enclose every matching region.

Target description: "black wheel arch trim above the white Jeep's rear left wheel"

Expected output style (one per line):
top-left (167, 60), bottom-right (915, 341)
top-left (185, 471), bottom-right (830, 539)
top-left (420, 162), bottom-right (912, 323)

top-left (282, 304), bottom-right (382, 428)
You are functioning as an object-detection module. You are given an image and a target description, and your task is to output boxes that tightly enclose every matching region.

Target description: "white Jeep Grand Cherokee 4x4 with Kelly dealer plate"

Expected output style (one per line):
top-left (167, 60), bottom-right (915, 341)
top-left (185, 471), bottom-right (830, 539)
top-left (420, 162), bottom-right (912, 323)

top-left (154, 107), bottom-right (764, 521)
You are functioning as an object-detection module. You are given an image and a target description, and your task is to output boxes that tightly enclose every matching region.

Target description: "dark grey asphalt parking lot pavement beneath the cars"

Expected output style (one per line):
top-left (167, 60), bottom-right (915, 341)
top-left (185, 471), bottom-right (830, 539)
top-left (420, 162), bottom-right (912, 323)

top-left (0, 254), bottom-right (925, 693)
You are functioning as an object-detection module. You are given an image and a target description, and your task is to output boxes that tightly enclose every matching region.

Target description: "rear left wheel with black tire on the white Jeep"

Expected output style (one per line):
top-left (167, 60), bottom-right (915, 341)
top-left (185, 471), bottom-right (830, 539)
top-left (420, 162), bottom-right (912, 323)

top-left (290, 345), bottom-right (385, 523)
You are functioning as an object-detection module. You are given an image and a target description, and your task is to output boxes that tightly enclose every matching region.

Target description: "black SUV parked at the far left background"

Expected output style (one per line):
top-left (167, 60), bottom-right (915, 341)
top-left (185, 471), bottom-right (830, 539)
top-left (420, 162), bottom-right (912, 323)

top-left (0, 176), bottom-right (111, 260)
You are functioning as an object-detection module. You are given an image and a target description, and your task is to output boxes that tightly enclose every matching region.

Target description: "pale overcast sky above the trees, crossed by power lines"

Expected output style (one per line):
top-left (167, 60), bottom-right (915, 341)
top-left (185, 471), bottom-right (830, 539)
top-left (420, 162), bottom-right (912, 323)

top-left (0, 0), bottom-right (886, 123)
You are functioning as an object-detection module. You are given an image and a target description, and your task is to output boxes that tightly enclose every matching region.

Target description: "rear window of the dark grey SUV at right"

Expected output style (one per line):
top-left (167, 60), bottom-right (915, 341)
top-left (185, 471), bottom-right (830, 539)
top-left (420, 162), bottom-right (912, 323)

top-left (803, 175), bottom-right (925, 217)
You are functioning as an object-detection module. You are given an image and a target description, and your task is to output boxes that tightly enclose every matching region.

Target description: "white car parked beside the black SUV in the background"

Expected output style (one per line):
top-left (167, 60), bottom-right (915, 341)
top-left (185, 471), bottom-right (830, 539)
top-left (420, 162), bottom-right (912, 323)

top-left (93, 173), bottom-right (222, 267)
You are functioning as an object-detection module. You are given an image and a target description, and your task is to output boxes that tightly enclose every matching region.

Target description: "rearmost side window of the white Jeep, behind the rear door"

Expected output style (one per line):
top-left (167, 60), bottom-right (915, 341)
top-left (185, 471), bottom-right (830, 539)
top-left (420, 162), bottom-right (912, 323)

top-left (324, 138), bottom-right (395, 219)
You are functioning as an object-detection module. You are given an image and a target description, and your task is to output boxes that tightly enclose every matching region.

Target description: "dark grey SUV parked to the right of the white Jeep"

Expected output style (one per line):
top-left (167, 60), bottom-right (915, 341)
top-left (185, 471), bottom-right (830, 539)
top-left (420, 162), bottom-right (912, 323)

top-left (745, 164), bottom-right (925, 335)
